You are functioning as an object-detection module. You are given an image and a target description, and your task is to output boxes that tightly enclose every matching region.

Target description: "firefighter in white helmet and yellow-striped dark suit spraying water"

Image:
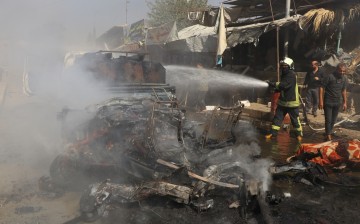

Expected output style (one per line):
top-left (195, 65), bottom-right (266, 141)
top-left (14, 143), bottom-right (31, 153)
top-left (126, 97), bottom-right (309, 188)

top-left (265, 57), bottom-right (302, 141)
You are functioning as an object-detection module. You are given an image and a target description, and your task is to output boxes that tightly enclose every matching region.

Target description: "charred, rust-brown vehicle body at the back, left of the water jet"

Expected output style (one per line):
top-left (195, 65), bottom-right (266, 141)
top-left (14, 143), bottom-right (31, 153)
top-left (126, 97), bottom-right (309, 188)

top-left (64, 51), bottom-right (166, 85)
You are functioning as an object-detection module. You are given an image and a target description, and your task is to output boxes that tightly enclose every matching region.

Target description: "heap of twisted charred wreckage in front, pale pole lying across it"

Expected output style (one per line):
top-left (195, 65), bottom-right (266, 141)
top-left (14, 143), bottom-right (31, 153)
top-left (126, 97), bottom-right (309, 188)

top-left (74, 117), bottom-right (269, 221)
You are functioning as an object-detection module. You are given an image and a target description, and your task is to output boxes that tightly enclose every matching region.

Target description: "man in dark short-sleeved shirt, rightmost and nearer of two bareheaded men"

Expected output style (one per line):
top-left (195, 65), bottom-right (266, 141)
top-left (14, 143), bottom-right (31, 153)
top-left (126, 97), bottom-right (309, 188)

top-left (319, 63), bottom-right (347, 141)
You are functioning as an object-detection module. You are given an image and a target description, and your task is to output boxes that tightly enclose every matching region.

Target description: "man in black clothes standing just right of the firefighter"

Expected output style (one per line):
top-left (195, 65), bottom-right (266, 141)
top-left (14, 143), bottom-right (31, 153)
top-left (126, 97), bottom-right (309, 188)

top-left (304, 60), bottom-right (324, 117)
